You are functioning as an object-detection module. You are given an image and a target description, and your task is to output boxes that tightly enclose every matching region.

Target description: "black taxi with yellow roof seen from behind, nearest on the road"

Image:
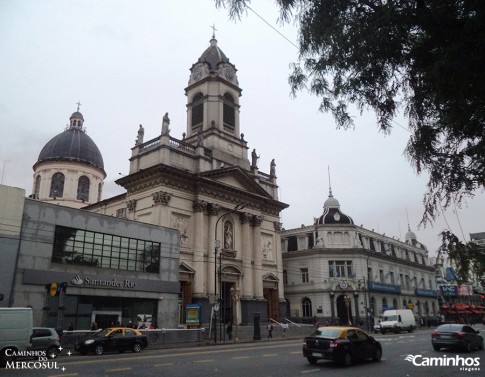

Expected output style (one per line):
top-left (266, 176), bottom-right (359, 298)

top-left (303, 326), bottom-right (382, 366)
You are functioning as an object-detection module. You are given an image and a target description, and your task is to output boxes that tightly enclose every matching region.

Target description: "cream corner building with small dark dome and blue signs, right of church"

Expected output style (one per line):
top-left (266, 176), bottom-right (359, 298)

top-left (281, 188), bottom-right (439, 330)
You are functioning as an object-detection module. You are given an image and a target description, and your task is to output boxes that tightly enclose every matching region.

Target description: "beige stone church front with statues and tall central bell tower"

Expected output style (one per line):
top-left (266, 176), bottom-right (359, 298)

top-left (85, 37), bottom-right (288, 324)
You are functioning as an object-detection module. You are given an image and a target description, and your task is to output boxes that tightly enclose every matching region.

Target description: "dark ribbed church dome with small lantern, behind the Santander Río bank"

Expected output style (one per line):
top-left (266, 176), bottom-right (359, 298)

top-left (36, 111), bottom-right (104, 171)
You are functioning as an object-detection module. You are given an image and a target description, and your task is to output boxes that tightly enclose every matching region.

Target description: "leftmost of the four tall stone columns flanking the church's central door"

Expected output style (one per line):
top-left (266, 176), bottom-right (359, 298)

top-left (192, 200), bottom-right (207, 297)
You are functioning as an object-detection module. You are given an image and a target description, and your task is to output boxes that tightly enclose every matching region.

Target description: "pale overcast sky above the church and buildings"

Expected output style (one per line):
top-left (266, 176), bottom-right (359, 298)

top-left (0, 0), bottom-right (485, 255)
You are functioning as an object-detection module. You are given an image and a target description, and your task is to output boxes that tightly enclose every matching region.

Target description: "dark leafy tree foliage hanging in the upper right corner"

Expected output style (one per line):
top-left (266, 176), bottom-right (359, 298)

top-left (215, 0), bottom-right (485, 280)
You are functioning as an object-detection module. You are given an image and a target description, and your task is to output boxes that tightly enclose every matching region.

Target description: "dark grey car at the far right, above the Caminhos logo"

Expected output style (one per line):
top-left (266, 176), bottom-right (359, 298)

top-left (431, 323), bottom-right (483, 352)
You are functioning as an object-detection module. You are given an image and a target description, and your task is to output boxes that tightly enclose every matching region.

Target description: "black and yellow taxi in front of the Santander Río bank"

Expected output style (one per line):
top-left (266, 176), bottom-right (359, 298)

top-left (75, 327), bottom-right (148, 355)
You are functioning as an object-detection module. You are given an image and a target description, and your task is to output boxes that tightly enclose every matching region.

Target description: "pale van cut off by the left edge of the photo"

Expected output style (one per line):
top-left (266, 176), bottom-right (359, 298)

top-left (0, 308), bottom-right (33, 365)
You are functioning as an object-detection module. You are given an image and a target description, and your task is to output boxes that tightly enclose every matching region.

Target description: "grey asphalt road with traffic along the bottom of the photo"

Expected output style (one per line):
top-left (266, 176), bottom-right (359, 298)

top-left (0, 327), bottom-right (485, 377)
